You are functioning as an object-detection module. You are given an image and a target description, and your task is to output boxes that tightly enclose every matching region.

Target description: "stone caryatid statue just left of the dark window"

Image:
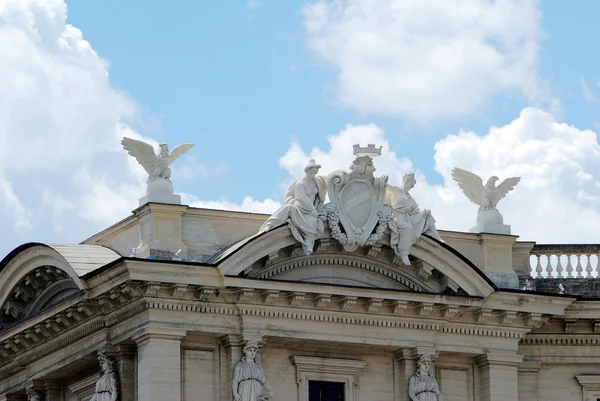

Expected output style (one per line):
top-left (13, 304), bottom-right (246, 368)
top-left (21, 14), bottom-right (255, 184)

top-left (233, 340), bottom-right (273, 401)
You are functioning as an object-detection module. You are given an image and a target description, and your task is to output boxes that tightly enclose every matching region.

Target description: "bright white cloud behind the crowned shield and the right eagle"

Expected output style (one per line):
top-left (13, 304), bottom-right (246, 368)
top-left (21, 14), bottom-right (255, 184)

top-left (270, 108), bottom-right (600, 243)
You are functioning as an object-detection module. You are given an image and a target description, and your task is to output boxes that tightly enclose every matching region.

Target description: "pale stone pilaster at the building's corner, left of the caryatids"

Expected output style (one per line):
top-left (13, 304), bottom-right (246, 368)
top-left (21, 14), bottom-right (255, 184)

top-left (133, 329), bottom-right (185, 401)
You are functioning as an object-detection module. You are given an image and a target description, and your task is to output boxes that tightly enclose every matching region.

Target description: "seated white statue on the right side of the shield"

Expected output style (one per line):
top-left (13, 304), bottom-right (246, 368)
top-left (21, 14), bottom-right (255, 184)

top-left (386, 173), bottom-right (444, 265)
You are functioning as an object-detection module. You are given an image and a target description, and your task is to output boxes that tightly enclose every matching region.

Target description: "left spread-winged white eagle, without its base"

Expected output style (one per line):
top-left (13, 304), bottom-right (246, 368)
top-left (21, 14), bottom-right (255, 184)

top-left (121, 137), bottom-right (194, 183)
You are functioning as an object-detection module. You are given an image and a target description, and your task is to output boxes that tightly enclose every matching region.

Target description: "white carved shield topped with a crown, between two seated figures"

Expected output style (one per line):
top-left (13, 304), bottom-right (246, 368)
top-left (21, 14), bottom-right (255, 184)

top-left (324, 144), bottom-right (392, 252)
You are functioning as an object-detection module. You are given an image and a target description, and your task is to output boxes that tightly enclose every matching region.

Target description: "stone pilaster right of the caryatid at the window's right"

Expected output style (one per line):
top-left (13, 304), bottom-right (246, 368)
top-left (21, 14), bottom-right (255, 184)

top-left (475, 354), bottom-right (523, 401)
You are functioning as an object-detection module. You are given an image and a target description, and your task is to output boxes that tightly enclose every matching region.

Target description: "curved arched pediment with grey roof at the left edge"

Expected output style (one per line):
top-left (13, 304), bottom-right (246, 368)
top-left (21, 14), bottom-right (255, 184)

top-left (0, 243), bottom-right (119, 330)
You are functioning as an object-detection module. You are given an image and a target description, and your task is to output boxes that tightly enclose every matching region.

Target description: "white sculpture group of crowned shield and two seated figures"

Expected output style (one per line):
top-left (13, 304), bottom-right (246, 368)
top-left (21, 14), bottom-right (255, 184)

top-left (260, 144), bottom-right (441, 265)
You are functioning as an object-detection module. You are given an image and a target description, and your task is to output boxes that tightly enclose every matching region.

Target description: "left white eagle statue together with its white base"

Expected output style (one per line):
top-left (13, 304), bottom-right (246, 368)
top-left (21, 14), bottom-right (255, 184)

top-left (121, 137), bottom-right (194, 205)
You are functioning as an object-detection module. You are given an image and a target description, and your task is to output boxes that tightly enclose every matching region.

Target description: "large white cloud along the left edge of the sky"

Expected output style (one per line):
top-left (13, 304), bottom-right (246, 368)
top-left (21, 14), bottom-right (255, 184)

top-left (0, 0), bottom-right (159, 253)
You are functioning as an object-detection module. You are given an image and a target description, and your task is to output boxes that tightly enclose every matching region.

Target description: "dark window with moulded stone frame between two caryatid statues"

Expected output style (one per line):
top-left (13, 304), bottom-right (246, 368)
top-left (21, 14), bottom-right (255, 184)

top-left (290, 356), bottom-right (367, 401)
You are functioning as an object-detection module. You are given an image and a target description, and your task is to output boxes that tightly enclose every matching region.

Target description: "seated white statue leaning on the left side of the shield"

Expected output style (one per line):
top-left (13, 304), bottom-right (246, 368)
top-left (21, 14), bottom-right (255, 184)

top-left (260, 159), bottom-right (327, 254)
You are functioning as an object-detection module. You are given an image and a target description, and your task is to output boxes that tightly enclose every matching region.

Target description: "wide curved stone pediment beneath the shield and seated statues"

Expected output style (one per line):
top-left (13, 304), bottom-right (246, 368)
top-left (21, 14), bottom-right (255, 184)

top-left (218, 226), bottom-right (495, 297)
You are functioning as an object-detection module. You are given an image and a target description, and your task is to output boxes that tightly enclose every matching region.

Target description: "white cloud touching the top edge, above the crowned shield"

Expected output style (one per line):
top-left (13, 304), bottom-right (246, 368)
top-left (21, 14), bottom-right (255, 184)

top-left (302, 0), bottom-right (544, 121)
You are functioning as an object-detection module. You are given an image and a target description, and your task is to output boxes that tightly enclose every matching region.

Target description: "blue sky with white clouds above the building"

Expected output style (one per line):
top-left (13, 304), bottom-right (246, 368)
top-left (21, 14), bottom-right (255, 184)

top-left (0, 0), bottom-right (600, 255)
